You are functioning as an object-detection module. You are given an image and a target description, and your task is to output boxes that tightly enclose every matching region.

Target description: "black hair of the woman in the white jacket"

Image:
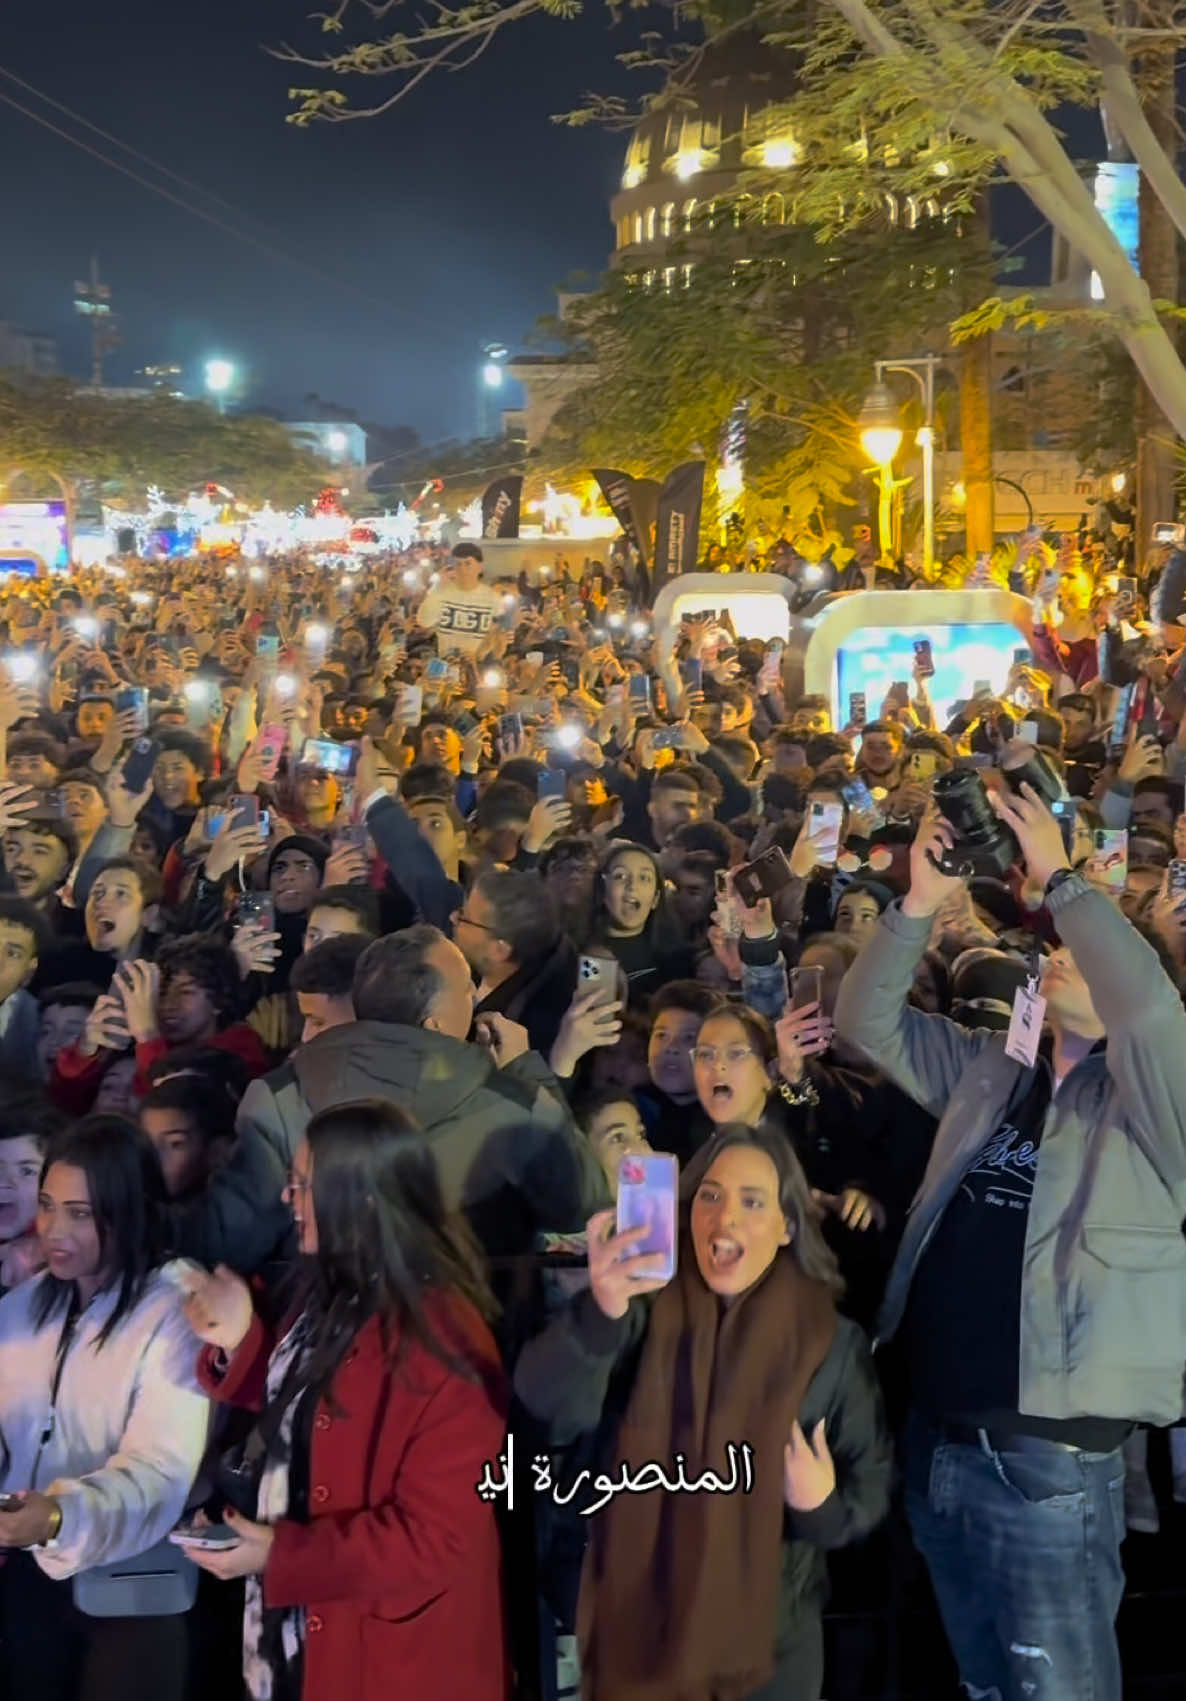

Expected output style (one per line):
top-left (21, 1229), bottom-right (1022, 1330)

top-left (32, 1114), bottom-right (165, 1347)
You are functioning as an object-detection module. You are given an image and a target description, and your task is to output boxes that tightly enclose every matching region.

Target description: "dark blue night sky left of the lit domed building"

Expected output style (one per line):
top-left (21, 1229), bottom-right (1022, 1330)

top-left (0, 0), bottom-right (624, 442)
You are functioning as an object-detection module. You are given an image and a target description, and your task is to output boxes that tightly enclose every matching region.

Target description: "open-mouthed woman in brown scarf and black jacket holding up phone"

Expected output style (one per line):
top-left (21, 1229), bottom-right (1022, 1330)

top-left (516, 1126), bottom-right (890, 1701)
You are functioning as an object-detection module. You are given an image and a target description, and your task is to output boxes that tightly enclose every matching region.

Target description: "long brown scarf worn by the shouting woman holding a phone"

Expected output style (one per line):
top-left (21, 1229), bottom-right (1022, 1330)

top-left (579, 1237), bottom-right (835, 1701)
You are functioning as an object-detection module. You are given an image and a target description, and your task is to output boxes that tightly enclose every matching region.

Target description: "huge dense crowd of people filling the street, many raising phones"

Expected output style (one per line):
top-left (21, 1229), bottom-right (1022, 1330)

top-left (0, 538), bottom-right (1186, 1701)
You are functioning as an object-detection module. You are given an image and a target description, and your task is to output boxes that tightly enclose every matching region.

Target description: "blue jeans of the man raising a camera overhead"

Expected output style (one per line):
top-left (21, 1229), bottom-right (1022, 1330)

top-left (905, 1415), bottom-right (1125, 1701)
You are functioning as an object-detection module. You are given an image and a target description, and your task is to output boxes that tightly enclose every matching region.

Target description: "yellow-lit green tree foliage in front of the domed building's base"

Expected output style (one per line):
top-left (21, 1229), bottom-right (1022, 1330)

top-left (541, 214), bottom-right (992, 527)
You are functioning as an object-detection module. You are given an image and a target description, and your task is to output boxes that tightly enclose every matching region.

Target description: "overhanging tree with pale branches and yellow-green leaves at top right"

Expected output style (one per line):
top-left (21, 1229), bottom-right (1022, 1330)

top-left (275, 0), bottom-right (1186, 435)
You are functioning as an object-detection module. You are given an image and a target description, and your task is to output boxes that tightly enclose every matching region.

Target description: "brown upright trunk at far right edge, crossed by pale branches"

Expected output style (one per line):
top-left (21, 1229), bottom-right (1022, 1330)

top-left (1137, 44), bottom-right (1177, 544)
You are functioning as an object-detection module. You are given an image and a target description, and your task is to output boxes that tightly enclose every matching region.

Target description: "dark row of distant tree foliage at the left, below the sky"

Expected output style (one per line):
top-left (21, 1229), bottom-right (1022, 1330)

top-left (0, 376), bottom-right (332, 507)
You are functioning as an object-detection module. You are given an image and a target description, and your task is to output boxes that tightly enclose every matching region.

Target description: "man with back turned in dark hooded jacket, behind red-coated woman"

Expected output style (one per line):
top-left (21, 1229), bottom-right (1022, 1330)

top-left (237, 924), bottom-right (606, 1257)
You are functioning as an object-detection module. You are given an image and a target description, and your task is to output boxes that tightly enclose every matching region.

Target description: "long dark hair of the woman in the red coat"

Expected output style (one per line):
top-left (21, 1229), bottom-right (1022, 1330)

top-left (290, 1099), bottom-right (495, 1395)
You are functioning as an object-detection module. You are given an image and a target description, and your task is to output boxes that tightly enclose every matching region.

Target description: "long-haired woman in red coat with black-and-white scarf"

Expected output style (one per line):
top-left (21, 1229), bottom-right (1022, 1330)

top-left (187, 1101), bottom-right (507, 1701)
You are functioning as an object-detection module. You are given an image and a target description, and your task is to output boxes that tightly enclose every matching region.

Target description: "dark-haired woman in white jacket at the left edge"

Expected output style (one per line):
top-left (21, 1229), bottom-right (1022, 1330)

top-left (0, 1116), bottom-right (209, 1701)
